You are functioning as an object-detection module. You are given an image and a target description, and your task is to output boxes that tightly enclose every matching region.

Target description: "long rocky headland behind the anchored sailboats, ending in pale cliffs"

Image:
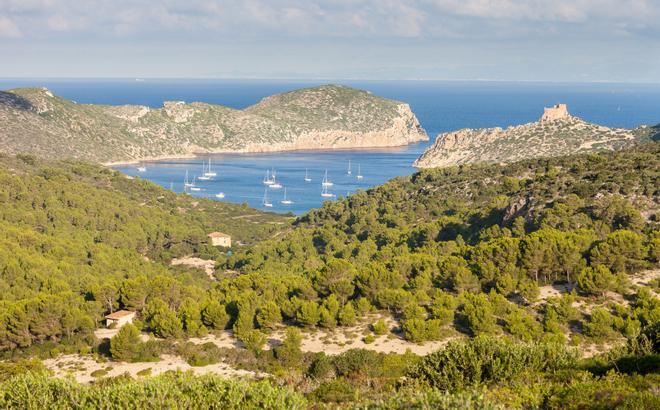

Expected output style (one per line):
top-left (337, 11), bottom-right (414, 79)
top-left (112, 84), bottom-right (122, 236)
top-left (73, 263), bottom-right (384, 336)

top-left (0, 85), bottom-right (428, 163)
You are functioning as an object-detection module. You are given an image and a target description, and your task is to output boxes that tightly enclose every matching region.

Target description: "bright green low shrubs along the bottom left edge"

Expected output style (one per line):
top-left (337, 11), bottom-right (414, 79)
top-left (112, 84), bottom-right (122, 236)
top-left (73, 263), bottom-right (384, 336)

top-left (0, 373), bottom-right (307, 410)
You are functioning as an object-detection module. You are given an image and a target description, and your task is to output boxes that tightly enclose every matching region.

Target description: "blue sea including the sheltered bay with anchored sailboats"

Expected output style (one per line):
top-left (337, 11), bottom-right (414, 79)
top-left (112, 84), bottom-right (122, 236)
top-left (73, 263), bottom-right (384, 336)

top-left (0, 79), bottom-right (660, 215)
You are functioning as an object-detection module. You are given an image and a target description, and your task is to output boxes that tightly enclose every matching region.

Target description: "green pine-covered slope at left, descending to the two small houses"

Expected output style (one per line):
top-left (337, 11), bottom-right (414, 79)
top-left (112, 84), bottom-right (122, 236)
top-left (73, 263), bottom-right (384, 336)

top-left (0, 156), bottom-right (290, 351)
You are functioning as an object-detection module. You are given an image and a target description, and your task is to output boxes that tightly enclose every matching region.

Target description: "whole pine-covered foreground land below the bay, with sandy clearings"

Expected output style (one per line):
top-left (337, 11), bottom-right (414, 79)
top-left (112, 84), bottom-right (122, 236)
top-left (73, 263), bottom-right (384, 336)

top-left (0, 142), bottom-right (660, 409)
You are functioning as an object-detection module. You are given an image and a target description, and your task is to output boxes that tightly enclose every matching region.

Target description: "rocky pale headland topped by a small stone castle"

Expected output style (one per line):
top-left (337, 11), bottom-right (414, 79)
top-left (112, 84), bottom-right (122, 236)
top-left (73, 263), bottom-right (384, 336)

top-left (414, 105), bottom-right (659, 168)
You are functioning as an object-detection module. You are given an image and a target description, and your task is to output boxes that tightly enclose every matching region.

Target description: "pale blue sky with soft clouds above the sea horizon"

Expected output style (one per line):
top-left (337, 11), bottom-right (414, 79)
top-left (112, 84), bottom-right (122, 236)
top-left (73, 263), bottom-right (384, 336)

top-left (0, 0), bottom-right (660, 83)
